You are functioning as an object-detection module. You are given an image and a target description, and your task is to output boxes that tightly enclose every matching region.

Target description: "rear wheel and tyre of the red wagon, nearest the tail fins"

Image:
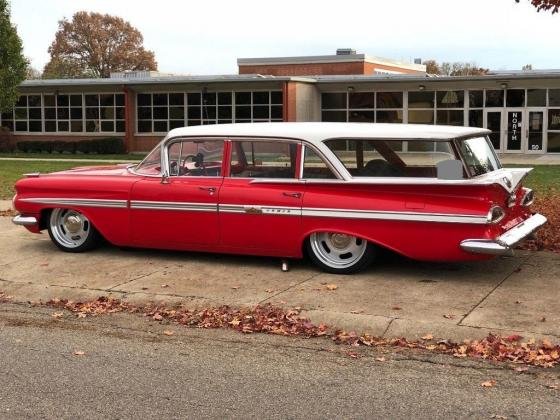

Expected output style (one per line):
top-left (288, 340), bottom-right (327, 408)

top-left (307, 232), bottom-right (376, 274)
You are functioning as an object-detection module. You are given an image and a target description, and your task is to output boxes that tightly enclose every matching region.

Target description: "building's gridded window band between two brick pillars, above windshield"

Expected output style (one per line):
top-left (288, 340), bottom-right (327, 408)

top-left (136, 91), bottom-right (283, 133)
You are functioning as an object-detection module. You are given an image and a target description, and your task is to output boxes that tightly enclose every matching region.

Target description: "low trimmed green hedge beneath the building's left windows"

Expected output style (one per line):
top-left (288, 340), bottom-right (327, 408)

top-left (17, 137), bottom-right (125, 155)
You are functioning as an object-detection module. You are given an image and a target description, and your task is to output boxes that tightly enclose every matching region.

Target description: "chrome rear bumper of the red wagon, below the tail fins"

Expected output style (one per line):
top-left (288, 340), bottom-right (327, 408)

top-left (461, 213), bottom-right (546, 255)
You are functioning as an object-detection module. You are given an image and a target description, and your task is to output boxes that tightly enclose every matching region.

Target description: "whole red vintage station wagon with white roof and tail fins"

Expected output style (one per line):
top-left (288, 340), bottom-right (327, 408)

top-left (13, 123), bottom-right (546, 273)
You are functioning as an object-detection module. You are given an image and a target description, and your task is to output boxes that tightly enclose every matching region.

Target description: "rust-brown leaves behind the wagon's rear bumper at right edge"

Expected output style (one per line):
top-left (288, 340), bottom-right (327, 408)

top-left (520, 193), bottom-right (560, 252)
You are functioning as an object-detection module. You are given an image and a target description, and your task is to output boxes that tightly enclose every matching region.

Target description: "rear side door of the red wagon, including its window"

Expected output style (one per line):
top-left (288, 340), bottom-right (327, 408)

top-left (219, 140), bottom-right (304, 256)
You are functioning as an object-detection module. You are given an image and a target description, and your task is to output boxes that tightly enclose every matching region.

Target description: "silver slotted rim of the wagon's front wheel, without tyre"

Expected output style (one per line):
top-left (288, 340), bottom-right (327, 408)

top-left (50, 209), bottom-right (91, 248)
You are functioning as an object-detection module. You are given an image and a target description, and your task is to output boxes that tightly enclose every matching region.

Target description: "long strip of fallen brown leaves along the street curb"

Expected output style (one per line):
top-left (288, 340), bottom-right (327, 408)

top-left (39, 293), bottom-right (560, 367)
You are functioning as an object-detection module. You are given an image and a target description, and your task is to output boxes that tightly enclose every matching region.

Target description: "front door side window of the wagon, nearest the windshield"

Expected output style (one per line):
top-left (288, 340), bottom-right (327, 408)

top-left (168, 140), bottom-right (224, 176)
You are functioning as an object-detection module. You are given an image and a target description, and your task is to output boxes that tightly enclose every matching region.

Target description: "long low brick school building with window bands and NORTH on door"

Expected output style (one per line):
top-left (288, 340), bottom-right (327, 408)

top-left (0, 50), bottom-right (560, 154)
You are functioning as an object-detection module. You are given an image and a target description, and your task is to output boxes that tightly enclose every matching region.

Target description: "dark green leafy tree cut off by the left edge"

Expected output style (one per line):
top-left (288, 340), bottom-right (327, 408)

top-left (0, 0), bottom-right (27, 112)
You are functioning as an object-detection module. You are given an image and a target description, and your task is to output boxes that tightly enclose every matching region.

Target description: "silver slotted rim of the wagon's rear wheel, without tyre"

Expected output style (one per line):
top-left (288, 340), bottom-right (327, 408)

top-left (310, 232), bottom-right (367, 268)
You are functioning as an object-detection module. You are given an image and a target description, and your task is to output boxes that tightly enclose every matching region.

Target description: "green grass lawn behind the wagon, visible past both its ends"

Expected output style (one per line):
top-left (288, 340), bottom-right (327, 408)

top-left (0, 161), bottom-right (560, 200)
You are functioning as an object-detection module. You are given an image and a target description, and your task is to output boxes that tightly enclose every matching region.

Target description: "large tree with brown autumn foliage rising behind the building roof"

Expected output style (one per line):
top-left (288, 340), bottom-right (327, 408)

top-left (43, 12), bottom-right (157, 78)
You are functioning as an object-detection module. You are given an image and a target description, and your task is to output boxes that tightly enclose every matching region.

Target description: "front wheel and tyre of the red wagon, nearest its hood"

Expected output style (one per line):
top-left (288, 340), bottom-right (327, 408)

top-left (48, 209), bottom-right (101, 252)
